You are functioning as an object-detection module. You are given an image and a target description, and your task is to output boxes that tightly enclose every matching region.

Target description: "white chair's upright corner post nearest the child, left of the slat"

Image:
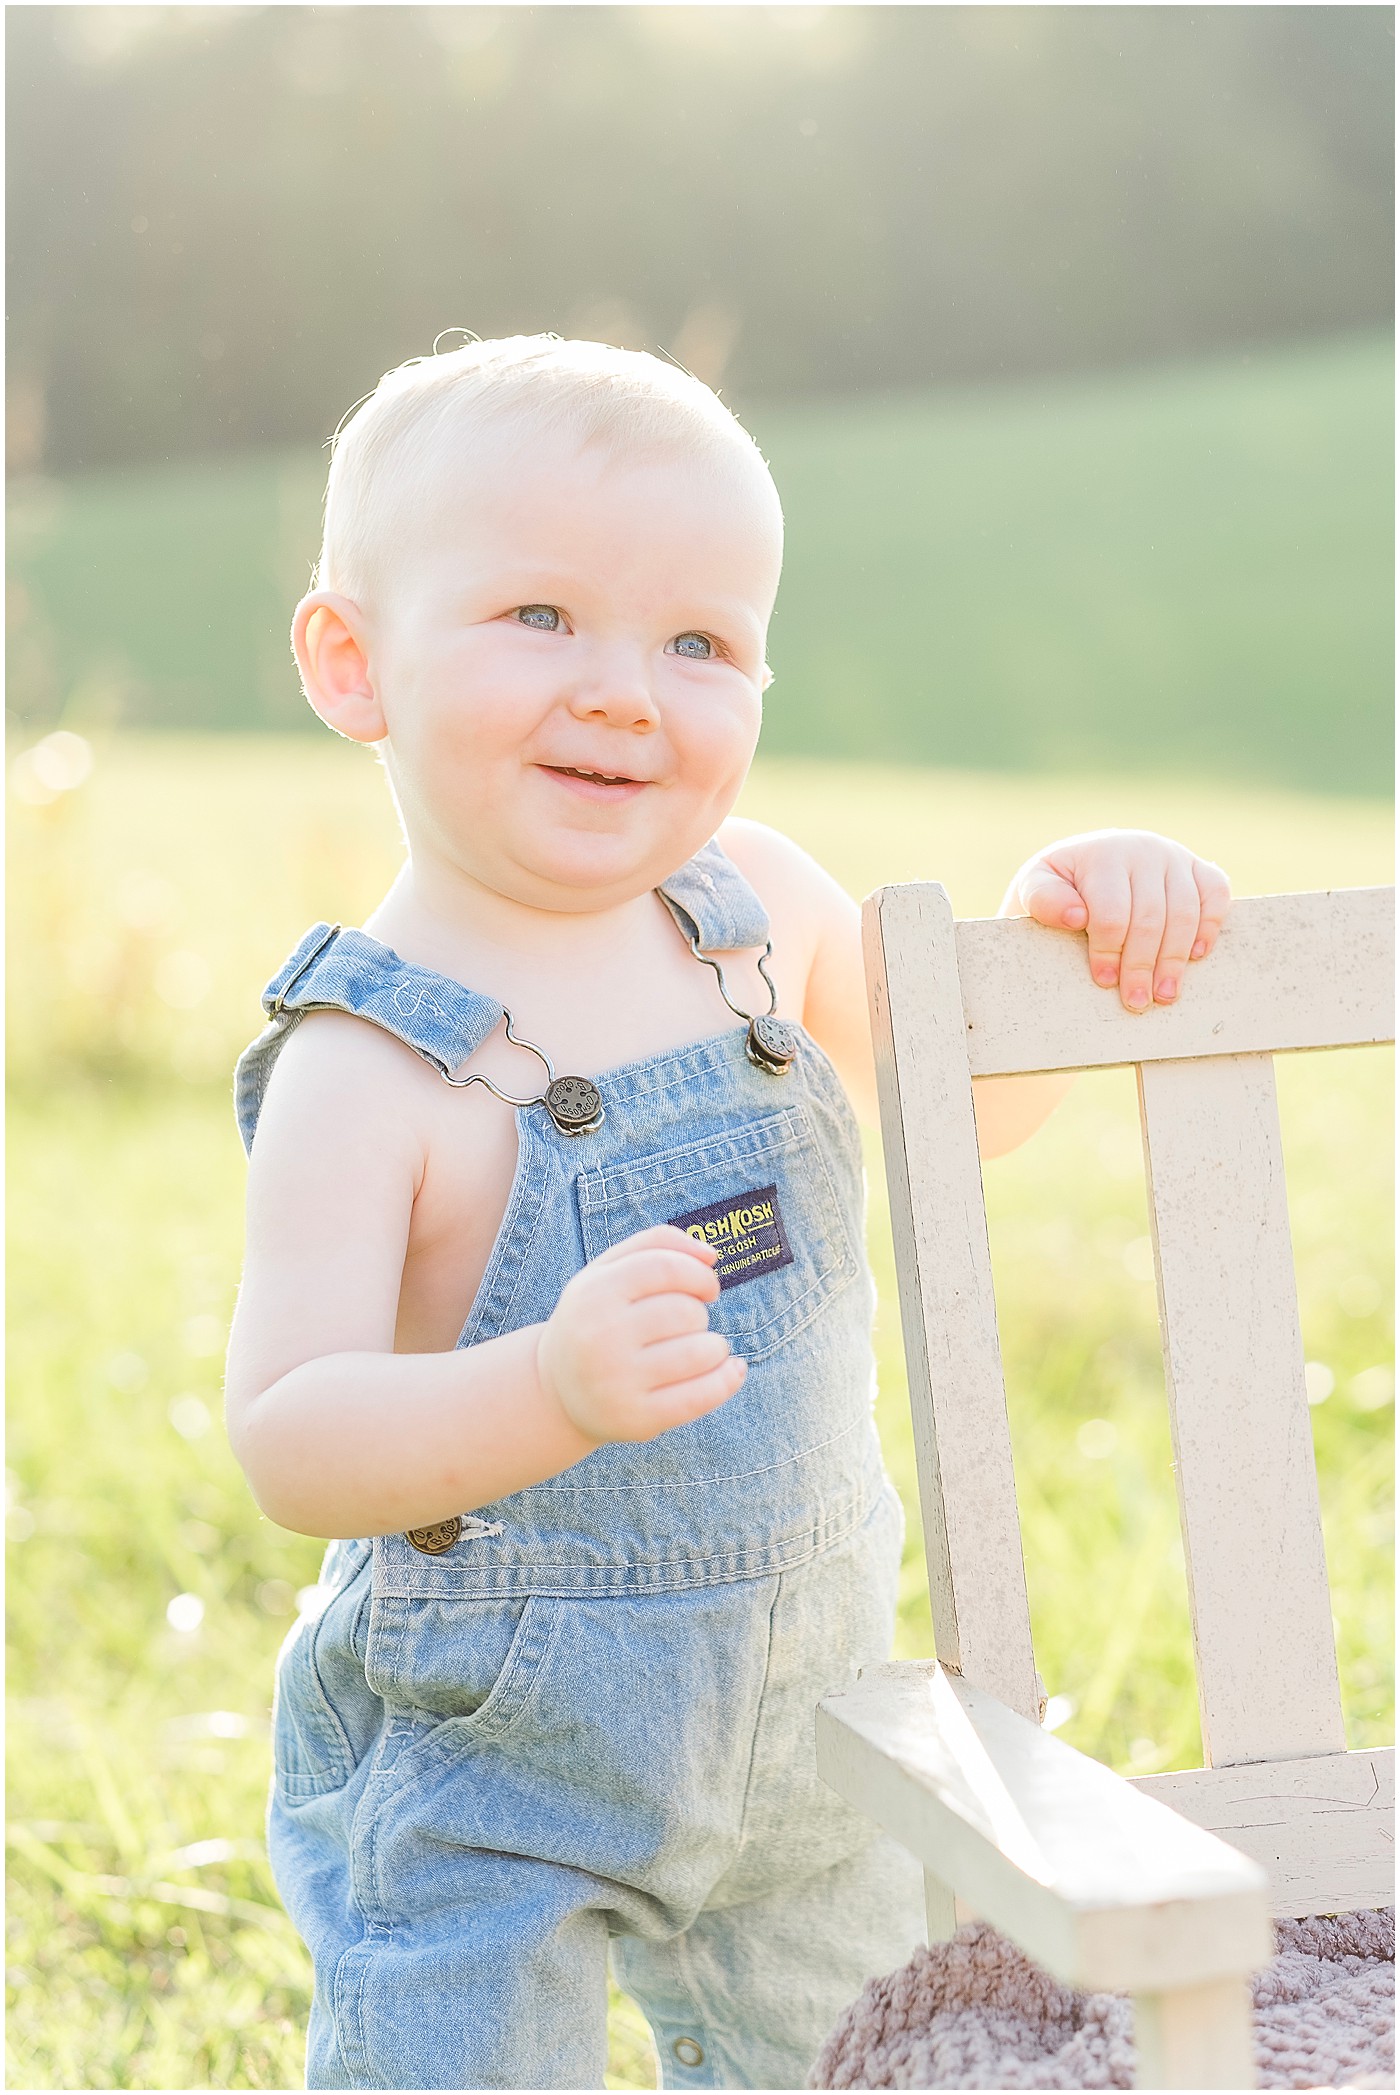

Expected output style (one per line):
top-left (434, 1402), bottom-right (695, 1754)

top-left (863, 884), bottom-right (1040, 1718)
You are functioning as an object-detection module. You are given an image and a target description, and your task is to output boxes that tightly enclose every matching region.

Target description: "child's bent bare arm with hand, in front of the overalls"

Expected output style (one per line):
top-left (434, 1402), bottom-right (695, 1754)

top-left (226, 1016), bottom-right (744, 1536)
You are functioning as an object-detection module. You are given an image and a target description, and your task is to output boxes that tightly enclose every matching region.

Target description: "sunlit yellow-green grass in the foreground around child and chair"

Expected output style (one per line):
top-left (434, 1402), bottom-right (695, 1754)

top-left (8, 737), bottom-right (1394, 2089)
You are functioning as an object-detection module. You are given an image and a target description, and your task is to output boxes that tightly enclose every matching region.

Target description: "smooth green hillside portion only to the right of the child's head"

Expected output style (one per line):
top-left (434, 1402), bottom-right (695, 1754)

top-left (759, 337), bottom-right (1394, 794)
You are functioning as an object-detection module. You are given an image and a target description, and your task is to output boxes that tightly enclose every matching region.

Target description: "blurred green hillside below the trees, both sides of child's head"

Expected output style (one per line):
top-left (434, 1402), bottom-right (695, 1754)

top-left (8, 335), bottom-right (1394, 796)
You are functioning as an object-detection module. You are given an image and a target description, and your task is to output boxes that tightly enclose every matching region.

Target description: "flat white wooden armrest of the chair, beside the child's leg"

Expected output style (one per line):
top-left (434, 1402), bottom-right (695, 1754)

top-left (817, 1659), bottom-right (1274, 1994)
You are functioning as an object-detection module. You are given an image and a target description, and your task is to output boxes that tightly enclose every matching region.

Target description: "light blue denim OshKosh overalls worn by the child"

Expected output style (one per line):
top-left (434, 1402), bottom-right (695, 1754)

top-left (237, 844), bottom-right (922, 2089)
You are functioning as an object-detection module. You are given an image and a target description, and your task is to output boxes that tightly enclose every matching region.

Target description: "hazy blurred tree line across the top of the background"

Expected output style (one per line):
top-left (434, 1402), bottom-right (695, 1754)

top-left (6, 6), bottom-right (1394, 473)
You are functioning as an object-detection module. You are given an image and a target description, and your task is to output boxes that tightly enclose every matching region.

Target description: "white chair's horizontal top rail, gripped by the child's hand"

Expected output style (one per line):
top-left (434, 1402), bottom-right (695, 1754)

top-left (958, 888), bottom-right (1396, 1077)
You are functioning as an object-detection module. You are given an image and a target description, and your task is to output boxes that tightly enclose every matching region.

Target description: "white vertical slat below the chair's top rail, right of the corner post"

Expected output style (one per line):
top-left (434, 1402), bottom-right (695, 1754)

top-left (1138, 1054), bottom-right (1346, 1768)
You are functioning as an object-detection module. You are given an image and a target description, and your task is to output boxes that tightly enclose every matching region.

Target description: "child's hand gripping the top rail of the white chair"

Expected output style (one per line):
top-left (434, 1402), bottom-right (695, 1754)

top-left (1002, 830), bottom-right (1230, 1012)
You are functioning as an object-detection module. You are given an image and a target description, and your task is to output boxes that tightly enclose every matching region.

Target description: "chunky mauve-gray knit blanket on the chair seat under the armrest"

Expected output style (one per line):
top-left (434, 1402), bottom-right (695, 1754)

top-left (807, 1909), bottom-right (1396, 2089)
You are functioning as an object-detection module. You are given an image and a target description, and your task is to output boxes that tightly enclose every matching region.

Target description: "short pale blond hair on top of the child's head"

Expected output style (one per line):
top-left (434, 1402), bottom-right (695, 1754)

top-left (312, 329), bottom-right (782, 601)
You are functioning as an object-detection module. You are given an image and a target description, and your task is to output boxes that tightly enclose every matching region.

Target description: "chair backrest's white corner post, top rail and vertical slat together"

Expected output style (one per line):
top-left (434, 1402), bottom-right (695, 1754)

top-left (866, 884), bottom-right (1394, 1768)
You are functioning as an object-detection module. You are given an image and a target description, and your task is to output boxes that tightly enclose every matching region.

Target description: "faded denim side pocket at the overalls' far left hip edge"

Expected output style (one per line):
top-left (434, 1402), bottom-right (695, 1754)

top-left (272, 1542), bottom-right (384, 1804)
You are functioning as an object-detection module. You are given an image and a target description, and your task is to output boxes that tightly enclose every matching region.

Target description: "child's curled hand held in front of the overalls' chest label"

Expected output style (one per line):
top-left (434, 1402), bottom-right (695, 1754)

top-left (539, 1223), bottom-right (748, 1441)
